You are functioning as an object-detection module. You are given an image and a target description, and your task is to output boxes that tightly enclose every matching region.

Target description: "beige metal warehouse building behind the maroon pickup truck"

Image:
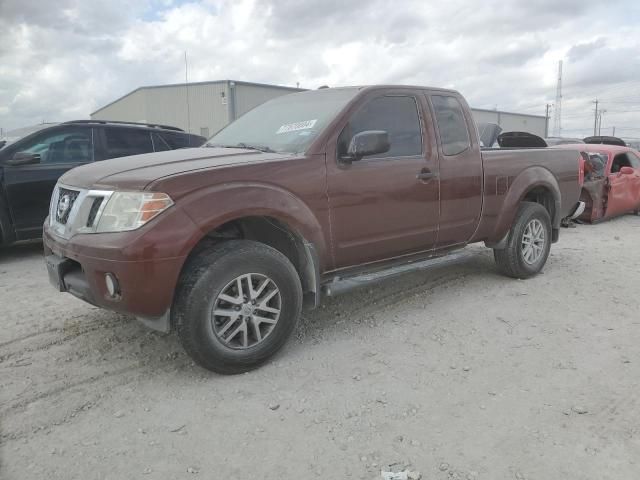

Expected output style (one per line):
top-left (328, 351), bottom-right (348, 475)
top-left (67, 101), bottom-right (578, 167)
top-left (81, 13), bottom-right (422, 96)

top-left (91, 80), bottom-right (547, 137)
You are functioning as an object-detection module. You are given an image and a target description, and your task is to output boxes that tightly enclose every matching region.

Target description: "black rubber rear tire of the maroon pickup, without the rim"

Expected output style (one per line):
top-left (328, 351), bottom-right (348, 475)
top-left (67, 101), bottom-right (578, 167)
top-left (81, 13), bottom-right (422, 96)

top-left (493, 202), bottom-right (552, 279)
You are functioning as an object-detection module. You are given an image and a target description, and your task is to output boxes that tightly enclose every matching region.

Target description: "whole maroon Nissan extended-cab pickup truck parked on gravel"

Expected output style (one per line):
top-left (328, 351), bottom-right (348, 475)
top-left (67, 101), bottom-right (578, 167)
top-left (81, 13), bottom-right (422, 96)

top-left (44, 86), bottom-right (581, 373)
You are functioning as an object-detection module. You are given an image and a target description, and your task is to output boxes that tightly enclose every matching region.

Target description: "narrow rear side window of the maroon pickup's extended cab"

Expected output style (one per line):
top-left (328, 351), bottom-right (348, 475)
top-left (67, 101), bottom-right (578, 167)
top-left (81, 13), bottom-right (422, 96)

top-left (431, 95), bottom-right (471, 155)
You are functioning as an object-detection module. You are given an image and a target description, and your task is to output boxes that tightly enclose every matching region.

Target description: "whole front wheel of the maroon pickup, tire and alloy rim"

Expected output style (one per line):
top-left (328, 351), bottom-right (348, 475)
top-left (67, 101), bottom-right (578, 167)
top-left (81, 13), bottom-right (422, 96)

top-left (173, 240), bottom-right (302, 374)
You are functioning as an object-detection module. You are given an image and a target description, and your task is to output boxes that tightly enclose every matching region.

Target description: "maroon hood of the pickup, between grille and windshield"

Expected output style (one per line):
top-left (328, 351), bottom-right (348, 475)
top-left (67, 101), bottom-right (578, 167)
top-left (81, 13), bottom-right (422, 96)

top-left (60, 147), bottom-right (289, 190)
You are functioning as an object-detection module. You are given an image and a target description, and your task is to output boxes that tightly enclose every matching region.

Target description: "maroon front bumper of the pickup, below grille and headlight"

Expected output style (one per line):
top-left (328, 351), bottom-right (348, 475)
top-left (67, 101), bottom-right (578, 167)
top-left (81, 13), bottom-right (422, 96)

top-left (43, 205), bottom-right (202, 330)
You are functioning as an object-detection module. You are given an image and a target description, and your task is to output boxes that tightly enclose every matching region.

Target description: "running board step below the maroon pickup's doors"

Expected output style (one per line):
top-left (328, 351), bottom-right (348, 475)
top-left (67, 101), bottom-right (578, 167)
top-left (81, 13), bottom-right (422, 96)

top-left (322, 252), bottom-right (474, 297)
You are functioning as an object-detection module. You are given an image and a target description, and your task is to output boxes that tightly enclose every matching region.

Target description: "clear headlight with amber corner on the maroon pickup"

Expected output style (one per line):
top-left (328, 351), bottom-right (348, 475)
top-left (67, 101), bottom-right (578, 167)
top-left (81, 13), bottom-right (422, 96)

top-left (95, 192), bottom-right (173, 233)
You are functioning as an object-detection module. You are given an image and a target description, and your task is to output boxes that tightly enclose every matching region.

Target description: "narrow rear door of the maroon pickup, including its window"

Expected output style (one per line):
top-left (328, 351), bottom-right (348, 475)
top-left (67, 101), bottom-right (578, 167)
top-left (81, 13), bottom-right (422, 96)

top-left (428, 92), bottom-right (483, 247)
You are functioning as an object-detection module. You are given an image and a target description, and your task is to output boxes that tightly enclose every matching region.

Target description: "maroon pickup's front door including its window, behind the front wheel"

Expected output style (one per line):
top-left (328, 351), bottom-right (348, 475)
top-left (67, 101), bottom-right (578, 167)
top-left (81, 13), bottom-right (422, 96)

top-left (327, 89), bottom-right (439, 268)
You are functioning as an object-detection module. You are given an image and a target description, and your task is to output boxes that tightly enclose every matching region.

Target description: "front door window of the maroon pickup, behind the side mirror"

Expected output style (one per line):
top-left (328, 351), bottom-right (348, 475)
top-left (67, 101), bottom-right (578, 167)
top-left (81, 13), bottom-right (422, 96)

top-left (338, 96), bottom-right (422, 158)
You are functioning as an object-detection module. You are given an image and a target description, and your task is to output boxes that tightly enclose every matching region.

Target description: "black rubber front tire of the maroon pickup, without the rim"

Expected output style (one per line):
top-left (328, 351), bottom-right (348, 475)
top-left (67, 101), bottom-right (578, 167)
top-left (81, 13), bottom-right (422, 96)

top-left (173, 240), bottom-right (302, 375)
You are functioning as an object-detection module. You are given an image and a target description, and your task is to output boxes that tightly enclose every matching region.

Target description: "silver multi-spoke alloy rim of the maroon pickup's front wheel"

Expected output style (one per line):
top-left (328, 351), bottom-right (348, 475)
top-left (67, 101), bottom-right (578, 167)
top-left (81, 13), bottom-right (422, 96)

top-left (211, 273), bottom-right (282, 350)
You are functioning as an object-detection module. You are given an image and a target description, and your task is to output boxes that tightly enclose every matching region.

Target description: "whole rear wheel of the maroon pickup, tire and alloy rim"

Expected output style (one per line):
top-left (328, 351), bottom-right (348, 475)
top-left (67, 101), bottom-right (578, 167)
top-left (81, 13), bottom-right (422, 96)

top-left (493, 202), bottom-right (551, 279)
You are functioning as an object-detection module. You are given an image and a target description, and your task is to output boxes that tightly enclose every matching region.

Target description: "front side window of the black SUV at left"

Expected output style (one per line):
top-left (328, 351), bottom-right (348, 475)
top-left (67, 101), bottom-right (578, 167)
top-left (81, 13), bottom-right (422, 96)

top-left (16, 127), bottom-right (93, 163)
